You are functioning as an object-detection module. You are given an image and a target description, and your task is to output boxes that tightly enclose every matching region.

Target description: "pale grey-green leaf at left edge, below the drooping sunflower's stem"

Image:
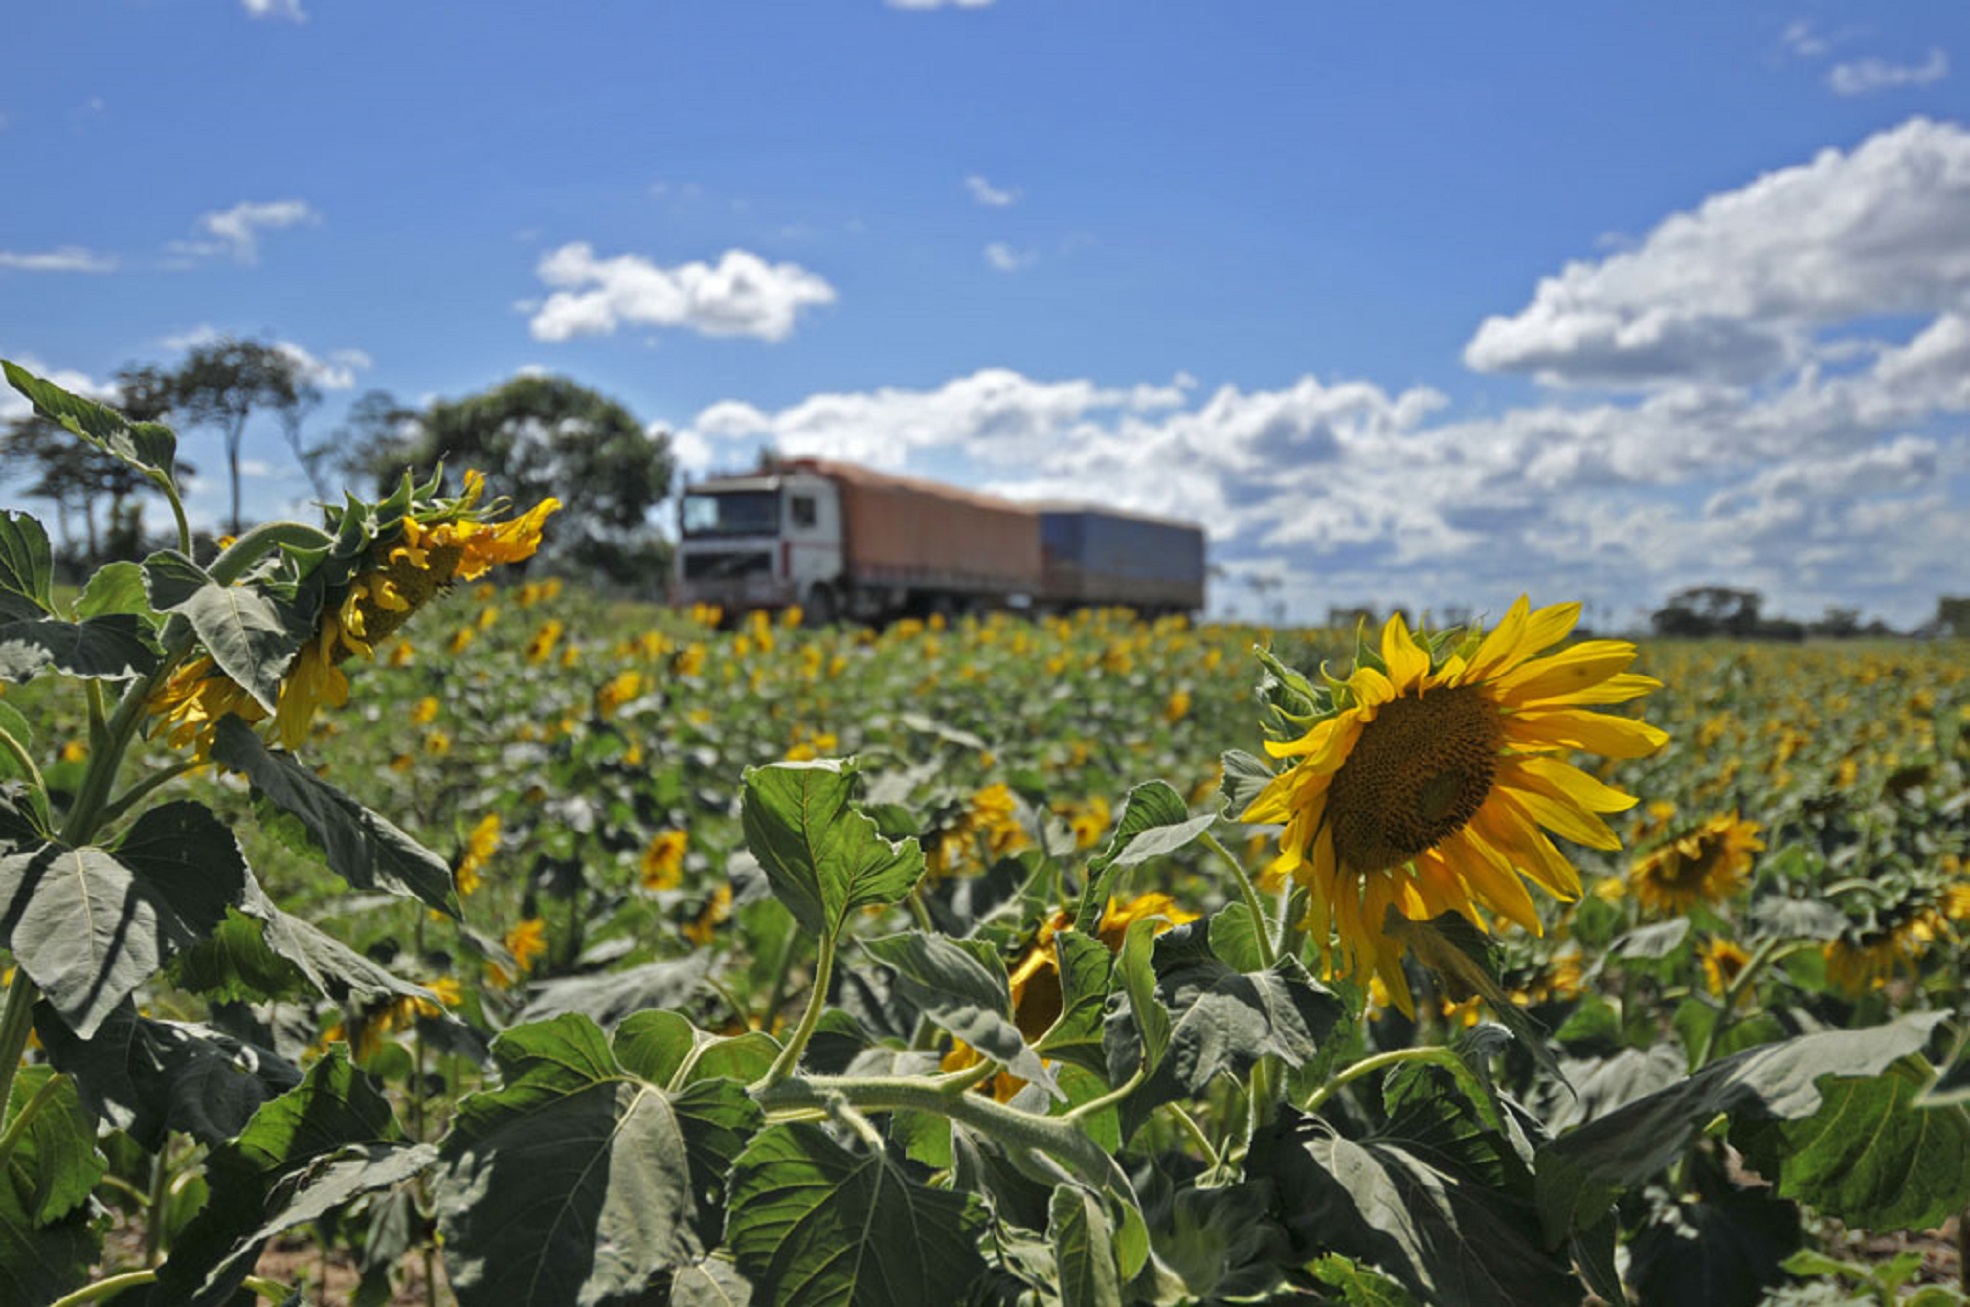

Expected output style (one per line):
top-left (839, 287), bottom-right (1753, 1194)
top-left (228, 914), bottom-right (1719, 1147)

top-left (0, 844), bottom-right (197, 1039)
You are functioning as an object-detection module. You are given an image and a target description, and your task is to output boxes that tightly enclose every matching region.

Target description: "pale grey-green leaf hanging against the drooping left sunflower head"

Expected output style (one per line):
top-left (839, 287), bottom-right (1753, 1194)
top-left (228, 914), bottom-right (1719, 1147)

top-left (144, 550), bottom-right (315, 712)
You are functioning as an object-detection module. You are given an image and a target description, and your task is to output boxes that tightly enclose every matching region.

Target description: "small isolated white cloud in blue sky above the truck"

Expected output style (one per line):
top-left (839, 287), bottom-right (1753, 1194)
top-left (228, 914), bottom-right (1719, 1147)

top-left (530, 241), bottom-right (835, 341)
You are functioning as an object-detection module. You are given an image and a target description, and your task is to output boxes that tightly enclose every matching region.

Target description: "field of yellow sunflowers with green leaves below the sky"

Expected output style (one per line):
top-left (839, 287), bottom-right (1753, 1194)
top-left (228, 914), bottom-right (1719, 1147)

top-left (0, 365), bottom-right (1970, 1307)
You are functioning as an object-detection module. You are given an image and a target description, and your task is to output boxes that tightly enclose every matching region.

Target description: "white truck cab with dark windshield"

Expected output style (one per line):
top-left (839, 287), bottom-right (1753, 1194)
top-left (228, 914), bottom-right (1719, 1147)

top-left (678, 471), bottom-right (843, 623)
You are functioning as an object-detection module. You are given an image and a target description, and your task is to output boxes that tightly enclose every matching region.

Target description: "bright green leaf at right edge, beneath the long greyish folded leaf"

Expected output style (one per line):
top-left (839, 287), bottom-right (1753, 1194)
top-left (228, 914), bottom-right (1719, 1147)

top-left (1779, 1059), bottom-right (1970, 1230)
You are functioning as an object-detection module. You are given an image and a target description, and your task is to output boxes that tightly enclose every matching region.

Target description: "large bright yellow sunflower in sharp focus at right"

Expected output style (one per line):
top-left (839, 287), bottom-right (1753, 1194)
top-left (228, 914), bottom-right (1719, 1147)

top-left (1239, 597), bottom-right (1669, 1013)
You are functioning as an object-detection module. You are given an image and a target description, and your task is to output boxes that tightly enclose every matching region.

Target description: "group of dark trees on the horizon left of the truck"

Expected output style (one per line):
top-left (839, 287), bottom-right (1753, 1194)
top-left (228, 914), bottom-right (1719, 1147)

top-left (0, 337), bottom-right (674, 593)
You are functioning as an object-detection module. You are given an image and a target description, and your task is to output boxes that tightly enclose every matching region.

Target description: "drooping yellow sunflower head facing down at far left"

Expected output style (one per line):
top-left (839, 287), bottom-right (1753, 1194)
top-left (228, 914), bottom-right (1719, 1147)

top-left (150, 471), bottom-right (561, 757)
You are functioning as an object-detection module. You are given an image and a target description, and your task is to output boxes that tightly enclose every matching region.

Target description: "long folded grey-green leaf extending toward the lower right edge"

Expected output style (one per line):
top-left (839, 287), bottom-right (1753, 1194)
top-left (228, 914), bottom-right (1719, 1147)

top-left (1537, 1011), bottom-right (1944, 1242)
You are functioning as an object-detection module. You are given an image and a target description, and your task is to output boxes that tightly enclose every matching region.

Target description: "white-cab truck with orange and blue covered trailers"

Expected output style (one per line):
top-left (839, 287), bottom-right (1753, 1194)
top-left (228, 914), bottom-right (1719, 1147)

top-left (674, 457), bottom-right (1204, 625)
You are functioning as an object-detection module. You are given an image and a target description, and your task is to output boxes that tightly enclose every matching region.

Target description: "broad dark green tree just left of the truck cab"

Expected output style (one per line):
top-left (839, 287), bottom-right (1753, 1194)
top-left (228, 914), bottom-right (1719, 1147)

top-left (362, 377), bottom-right (672, 585)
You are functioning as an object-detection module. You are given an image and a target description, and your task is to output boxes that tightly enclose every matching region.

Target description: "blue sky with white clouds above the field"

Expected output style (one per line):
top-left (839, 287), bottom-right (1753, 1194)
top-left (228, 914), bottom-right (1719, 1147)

top-left (0, 0), bottom-right (1970, 621)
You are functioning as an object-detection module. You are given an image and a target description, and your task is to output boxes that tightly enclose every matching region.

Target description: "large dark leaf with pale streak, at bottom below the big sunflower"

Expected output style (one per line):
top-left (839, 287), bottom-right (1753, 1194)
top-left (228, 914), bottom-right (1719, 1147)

top-left (1247, 1108), bottom-right (1582, 1307)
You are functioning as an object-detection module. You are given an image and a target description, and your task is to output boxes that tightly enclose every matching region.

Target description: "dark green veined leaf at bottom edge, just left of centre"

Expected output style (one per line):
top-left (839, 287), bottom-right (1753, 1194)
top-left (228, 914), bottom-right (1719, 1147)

top-left (725, 1124), bottom-right (985, 1307)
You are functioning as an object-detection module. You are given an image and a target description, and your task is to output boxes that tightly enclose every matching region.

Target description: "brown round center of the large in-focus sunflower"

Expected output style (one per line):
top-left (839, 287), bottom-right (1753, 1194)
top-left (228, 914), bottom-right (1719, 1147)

top-left (1328, 686), bottom-right (1505, 871)
